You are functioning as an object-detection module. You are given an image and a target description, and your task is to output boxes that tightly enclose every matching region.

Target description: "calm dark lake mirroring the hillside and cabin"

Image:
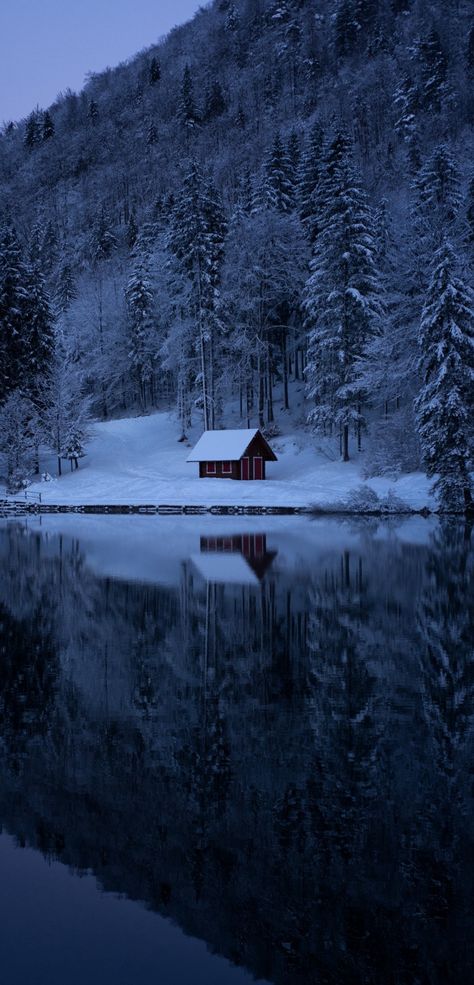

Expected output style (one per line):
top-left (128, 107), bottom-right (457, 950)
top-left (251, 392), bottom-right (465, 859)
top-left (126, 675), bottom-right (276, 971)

top-left (0, 517), bottom-right (474, 985)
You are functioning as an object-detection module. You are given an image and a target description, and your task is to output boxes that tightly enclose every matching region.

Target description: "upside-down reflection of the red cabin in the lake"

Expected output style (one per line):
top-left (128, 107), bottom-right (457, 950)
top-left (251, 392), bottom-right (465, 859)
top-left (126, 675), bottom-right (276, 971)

top-left (191, 534), bottom-right (278, 585)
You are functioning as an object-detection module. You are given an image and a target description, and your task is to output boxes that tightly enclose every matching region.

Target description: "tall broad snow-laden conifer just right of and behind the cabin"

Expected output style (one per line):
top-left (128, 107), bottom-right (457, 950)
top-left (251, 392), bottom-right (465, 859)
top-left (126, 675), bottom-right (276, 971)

top-left (303, 132), bottom-right (383, 461)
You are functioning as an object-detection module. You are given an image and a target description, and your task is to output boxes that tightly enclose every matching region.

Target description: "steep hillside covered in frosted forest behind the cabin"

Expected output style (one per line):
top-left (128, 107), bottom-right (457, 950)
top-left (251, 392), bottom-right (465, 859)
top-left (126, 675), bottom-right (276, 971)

top-left (0, 0), bottom-right (474, 507)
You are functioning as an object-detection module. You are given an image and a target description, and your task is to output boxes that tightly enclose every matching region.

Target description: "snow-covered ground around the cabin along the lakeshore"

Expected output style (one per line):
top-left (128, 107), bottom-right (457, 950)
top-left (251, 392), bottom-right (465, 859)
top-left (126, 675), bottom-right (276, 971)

top-left (0, 413), bottom-right (434, 509)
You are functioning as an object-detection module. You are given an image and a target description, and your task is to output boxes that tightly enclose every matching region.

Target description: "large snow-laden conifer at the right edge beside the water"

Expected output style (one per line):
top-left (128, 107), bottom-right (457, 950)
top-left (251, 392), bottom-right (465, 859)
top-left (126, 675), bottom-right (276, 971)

top-left (415, 241), bottom-right (474, 510)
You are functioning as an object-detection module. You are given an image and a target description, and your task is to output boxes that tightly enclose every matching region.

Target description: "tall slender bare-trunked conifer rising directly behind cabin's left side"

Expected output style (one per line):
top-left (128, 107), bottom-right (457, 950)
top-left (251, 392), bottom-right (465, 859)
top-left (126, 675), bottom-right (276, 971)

top-left (169, 162), bottom-right (226, 430)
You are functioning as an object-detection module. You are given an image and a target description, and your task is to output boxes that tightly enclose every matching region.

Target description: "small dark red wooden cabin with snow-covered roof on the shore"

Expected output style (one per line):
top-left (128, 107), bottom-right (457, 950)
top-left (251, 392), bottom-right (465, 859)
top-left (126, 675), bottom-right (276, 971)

top-left (187, 428), bottom-right (277, 479)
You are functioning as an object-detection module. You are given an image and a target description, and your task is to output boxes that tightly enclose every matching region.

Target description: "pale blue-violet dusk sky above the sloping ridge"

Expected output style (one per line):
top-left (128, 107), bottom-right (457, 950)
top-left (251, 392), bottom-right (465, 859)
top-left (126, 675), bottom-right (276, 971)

top-left (0, 0), bottom-right (204, 123)
